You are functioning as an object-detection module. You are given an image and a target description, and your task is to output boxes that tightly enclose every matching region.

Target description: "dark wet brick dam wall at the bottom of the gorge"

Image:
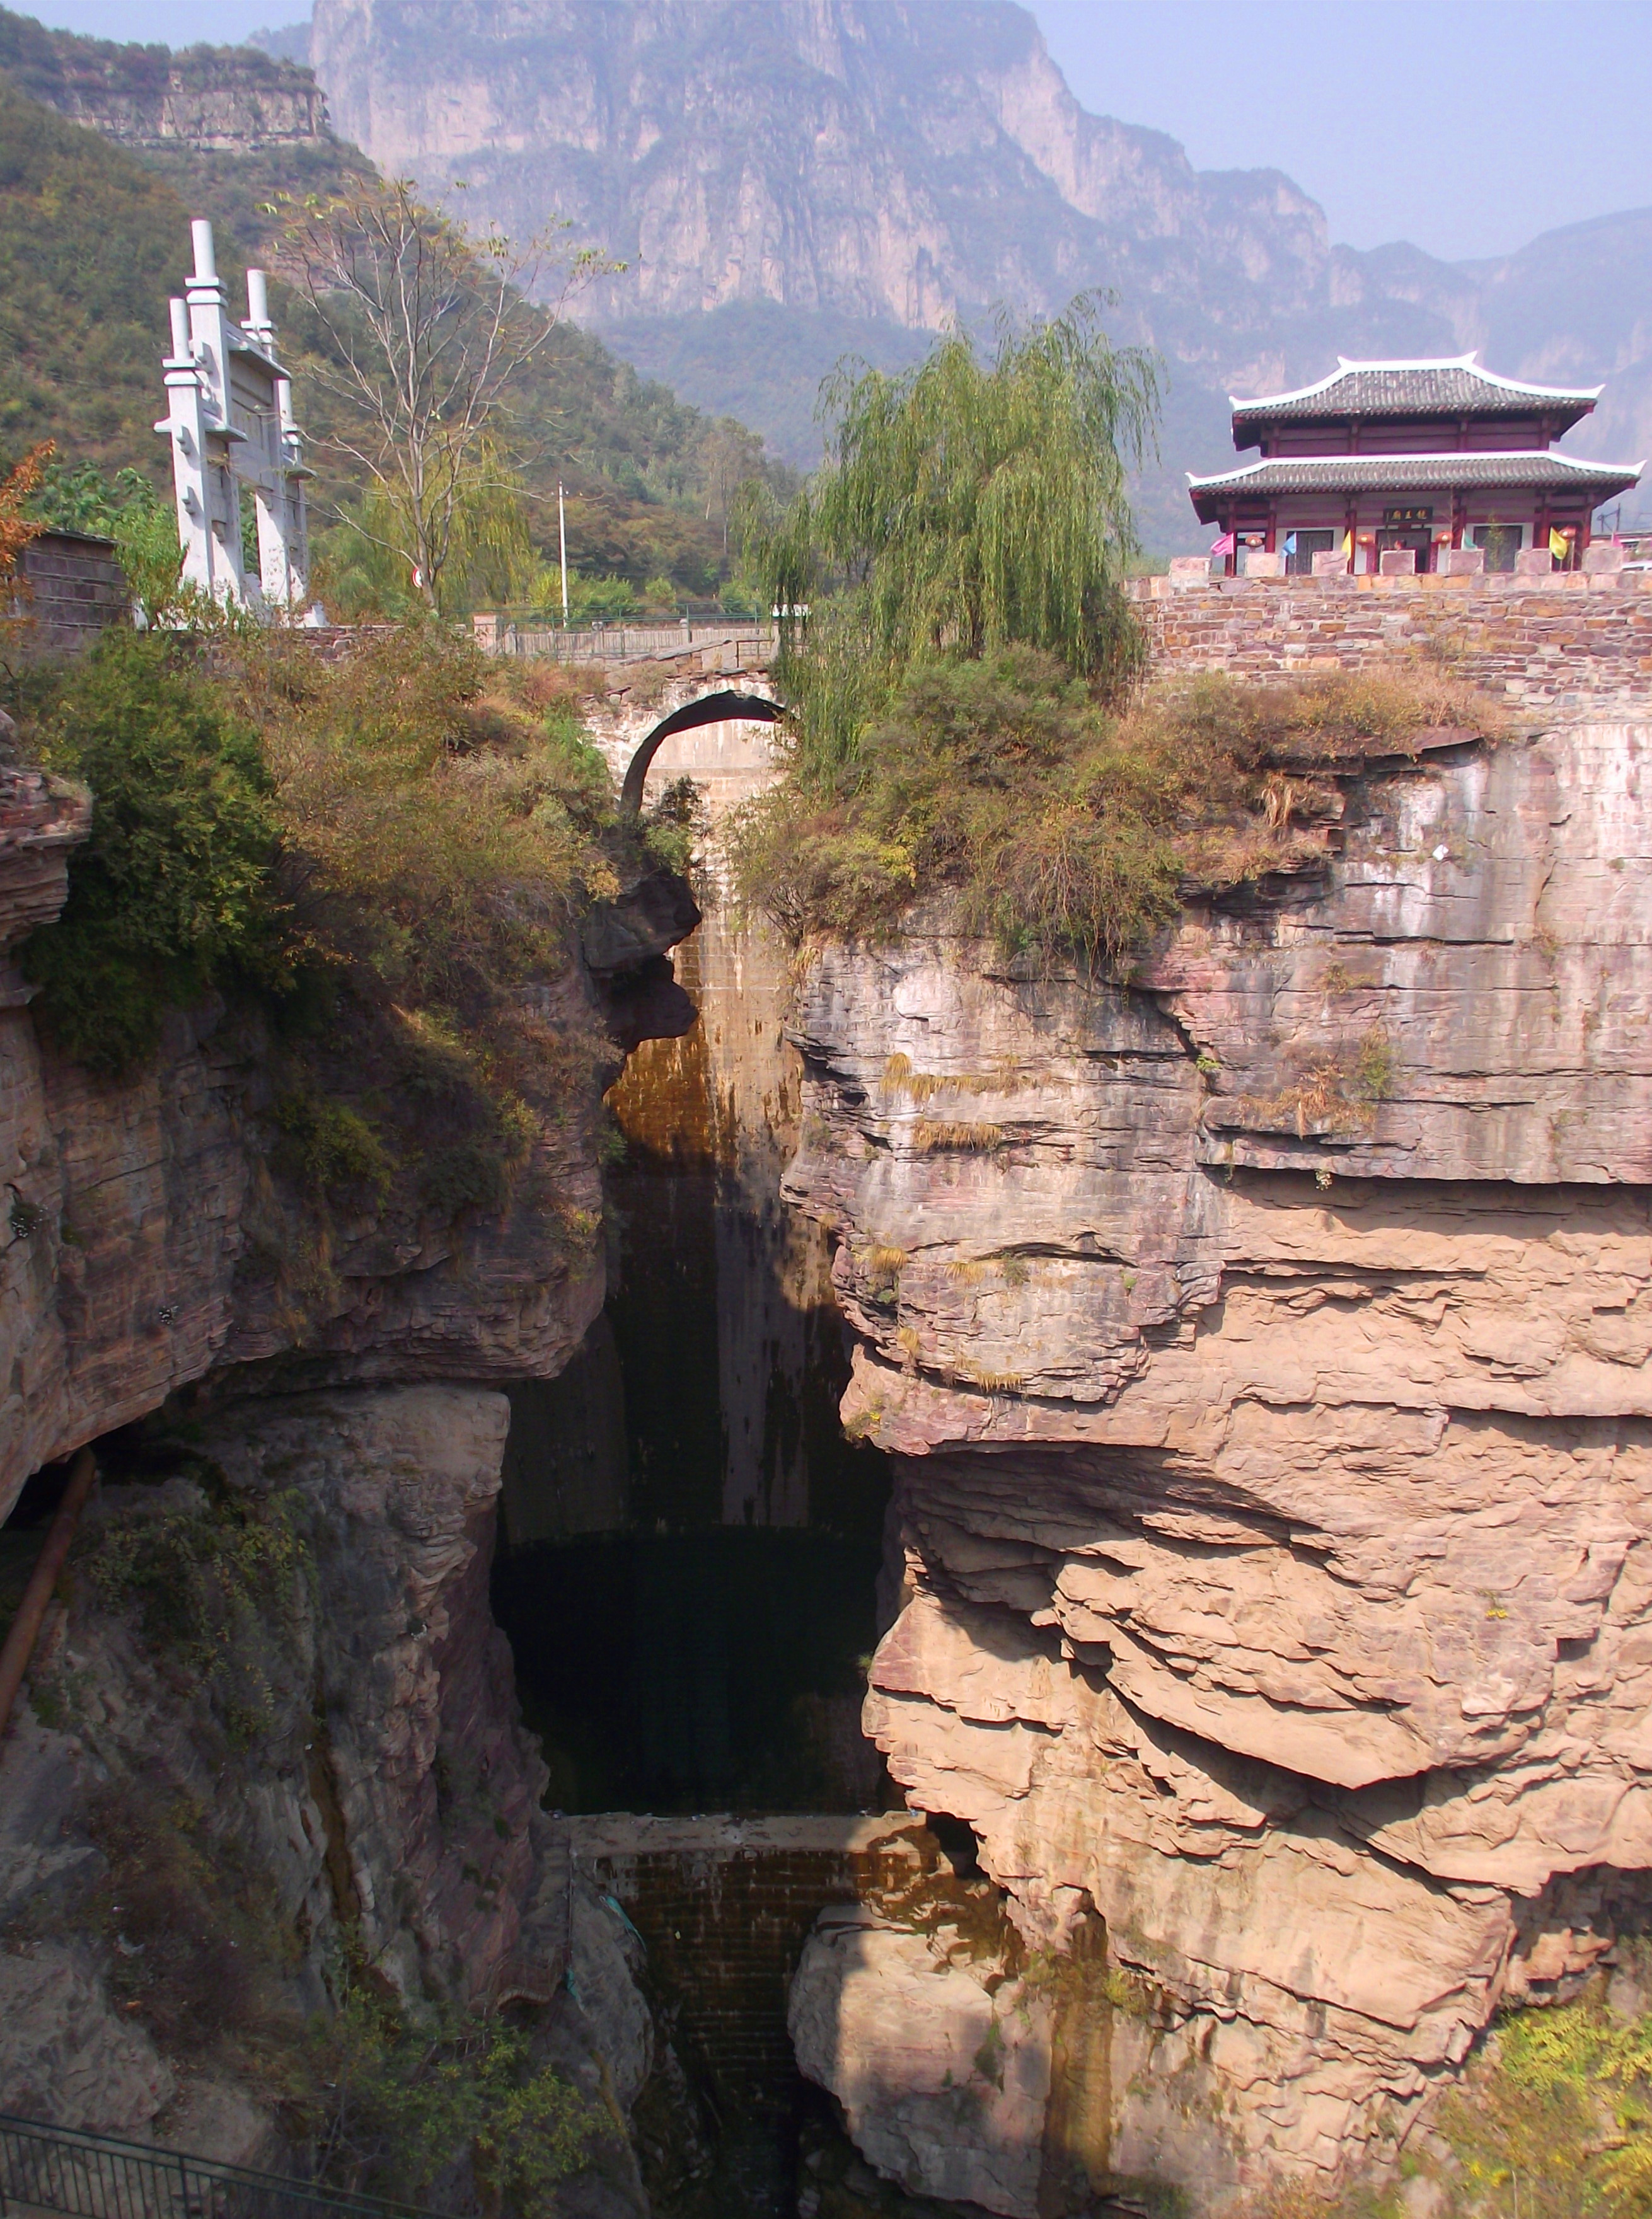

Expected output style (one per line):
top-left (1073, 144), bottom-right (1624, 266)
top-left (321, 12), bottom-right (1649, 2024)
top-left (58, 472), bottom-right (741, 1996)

top-left (569, 1813), bottom-right (939, 2121)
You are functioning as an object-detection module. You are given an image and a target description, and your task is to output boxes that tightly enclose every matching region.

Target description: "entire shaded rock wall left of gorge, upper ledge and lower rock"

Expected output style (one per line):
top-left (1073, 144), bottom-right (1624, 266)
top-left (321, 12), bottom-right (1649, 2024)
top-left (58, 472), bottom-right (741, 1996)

top-left (0, 750), bottom-right (697, 2183)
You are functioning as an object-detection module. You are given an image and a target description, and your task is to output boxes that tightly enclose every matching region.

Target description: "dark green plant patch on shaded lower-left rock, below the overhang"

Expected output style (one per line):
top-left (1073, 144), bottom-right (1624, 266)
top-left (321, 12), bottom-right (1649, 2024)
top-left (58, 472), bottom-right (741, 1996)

top-left (86, 1485), bottom-right (311, 1749)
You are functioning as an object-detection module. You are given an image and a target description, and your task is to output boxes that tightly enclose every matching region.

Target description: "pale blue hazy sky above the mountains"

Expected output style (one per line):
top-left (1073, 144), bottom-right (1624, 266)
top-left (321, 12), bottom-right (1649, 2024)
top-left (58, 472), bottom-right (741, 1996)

top-left (25, 0), bottom-right (1652, 260)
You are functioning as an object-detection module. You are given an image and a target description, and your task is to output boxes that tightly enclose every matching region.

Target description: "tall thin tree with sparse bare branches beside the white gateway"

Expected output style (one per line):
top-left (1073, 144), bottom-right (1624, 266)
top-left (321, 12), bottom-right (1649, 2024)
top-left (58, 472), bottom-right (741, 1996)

top-left (277, 178), bottom-right (615, 608)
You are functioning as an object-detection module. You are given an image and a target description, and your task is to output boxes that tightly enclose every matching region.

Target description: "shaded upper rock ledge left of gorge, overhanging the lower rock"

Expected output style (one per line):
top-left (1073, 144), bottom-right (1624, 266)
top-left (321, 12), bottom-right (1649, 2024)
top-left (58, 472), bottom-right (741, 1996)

top-left (0, 736), bottom-right (697, 1511)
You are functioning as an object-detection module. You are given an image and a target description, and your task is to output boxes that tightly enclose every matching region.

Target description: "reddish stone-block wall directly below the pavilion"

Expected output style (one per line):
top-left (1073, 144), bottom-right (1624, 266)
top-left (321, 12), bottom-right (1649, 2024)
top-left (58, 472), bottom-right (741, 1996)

top-left (1133, 572), bottom-right (1652, 717)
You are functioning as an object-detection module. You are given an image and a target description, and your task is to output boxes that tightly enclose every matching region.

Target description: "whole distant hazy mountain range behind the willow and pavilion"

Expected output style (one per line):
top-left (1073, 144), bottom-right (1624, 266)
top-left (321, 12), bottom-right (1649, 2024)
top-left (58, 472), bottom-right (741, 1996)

top-left (304, 0), bottom-right (1652, 546)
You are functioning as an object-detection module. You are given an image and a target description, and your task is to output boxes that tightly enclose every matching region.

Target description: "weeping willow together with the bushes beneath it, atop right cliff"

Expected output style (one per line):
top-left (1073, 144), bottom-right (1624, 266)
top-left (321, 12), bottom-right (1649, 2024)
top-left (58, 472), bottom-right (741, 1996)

top-left (733, 299), bottom-right (1510, 963)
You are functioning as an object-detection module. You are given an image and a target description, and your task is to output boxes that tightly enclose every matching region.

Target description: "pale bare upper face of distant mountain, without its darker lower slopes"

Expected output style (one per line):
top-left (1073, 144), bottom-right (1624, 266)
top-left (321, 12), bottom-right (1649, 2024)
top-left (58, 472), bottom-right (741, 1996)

top-left (311, 0), bottom-right (1368, 353)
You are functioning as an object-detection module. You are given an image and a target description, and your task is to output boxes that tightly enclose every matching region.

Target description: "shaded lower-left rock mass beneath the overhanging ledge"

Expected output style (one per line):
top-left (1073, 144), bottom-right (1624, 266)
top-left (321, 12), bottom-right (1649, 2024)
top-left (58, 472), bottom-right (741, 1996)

top-left (0, 1385), bottom-right (650, 2210)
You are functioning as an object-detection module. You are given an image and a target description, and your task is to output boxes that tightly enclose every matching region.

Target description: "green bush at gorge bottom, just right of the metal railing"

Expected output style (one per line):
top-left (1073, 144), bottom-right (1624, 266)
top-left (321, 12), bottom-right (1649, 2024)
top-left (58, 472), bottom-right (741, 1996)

top-left (318, 1984), bottom-right (613, 2219)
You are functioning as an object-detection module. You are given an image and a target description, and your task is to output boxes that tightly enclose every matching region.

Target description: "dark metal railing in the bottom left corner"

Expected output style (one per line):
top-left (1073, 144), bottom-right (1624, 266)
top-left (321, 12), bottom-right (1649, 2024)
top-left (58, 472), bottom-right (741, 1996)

top-left (0, 2112), bottom-right (437, 2219)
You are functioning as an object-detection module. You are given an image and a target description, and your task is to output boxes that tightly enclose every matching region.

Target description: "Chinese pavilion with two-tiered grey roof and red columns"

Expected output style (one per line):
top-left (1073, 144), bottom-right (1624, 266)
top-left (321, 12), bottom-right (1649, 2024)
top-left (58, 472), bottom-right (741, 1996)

top-left (1188, 355), bottom-right (1641, 572)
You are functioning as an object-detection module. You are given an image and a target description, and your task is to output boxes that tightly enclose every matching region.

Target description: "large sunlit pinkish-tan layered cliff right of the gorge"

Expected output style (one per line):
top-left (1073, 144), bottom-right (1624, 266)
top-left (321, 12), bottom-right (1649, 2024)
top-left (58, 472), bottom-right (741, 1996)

top-left (788, 723), bottom-right (1652, 2215)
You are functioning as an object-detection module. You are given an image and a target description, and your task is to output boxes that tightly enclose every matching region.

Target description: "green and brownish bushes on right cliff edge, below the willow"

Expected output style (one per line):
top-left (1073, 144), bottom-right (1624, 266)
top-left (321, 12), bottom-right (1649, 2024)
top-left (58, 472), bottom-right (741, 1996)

top-left (733, 648), bottom-right (1487, 972)
